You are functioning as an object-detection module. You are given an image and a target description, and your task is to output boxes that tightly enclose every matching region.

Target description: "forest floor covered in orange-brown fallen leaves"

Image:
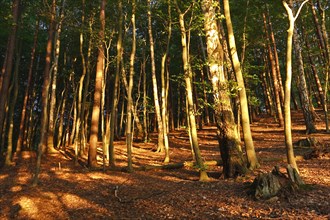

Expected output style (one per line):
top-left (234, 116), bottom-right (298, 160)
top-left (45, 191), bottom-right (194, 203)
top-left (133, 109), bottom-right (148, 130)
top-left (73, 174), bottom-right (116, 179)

top-left (0, 109), bottom-right (330, 219)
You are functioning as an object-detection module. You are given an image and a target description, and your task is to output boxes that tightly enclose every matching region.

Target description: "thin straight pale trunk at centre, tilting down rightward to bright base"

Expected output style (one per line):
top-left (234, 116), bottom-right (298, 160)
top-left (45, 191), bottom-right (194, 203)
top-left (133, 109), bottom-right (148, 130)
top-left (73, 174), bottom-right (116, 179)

top-left (147, 0), bottom-right (165, 152)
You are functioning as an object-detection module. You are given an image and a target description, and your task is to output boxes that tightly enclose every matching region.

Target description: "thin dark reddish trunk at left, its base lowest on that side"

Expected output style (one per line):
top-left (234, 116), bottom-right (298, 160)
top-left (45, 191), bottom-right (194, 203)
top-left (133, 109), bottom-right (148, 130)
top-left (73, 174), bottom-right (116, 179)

top-left (33, 0), bottom-right (56, 186)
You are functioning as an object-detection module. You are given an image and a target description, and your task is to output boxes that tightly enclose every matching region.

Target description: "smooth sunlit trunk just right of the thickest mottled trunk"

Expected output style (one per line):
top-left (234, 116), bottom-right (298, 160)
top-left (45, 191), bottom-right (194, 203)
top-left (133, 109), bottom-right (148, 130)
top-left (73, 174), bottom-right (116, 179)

top-left (223, 0), bottom-right (260, 170)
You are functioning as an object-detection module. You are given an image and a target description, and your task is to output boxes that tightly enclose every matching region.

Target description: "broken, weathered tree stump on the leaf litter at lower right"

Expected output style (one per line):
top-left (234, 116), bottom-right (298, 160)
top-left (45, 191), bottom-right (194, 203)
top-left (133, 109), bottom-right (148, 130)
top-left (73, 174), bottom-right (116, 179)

top-left (249, 165), bottom-right (304, 200)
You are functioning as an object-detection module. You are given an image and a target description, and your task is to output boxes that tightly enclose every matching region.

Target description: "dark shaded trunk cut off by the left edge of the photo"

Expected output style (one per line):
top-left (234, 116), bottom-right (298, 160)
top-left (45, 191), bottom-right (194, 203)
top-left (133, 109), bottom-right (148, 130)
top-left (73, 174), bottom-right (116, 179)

top-left (0, 0), bottom-right (21, 143)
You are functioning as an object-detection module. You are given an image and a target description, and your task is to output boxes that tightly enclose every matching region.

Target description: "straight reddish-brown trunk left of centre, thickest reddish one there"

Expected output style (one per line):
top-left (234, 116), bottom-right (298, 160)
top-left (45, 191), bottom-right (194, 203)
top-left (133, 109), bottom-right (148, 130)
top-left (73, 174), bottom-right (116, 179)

top-left (88, 0), bottom-right (106, 167)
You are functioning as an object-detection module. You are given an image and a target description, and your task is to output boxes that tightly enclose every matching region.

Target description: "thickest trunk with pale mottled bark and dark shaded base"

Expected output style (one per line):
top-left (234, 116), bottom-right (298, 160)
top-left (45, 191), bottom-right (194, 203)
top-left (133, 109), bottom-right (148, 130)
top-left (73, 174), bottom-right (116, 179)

top-left (202, 0), bottom-right (245, 178)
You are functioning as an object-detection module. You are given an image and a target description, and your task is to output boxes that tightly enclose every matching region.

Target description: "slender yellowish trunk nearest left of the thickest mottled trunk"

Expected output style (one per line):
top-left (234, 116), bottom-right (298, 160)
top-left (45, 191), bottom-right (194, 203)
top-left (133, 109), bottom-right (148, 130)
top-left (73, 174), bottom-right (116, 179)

top-left (175, 0), bottom-right (208, 181)
